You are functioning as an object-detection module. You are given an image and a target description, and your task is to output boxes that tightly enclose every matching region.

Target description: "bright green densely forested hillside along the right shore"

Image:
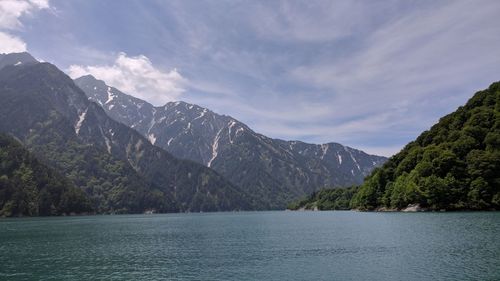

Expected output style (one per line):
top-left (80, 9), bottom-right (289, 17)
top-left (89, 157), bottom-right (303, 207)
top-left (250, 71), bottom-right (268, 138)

top-left (289, 82), bottom-right (500, 210)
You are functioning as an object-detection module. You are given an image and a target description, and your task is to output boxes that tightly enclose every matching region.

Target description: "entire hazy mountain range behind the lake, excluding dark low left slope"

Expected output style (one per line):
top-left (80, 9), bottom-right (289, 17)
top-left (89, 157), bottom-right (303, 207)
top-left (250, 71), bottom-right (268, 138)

top-left (0, 53), bottom-right (386, 214)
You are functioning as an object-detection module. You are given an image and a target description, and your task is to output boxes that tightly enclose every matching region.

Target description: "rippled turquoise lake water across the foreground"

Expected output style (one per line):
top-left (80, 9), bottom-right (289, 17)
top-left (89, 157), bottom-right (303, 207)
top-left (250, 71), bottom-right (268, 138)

top-left (0, 212), bottom-right (500, 280)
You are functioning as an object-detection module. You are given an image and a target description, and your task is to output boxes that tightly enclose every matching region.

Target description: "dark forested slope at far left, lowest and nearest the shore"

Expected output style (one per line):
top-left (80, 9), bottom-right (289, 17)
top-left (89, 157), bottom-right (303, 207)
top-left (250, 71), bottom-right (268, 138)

top-left (0, 134), bottom-right (91, 217)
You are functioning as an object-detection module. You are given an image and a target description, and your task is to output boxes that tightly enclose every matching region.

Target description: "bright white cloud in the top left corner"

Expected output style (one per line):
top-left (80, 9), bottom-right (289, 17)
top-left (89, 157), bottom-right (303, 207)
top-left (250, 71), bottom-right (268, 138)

top-left (0, 0), bottom-right (49, 53)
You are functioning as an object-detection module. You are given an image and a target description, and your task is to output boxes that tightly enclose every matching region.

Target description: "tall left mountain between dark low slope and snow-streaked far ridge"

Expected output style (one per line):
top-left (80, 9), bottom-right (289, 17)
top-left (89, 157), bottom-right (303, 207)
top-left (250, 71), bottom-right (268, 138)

top-left (0, 59), bottom-right (252, 213)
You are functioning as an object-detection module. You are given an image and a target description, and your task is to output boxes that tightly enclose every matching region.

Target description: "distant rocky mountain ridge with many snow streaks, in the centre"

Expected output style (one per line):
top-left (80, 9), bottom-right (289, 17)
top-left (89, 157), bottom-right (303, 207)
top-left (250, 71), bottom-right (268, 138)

top-left (75, 75), bottom-right (386, 209)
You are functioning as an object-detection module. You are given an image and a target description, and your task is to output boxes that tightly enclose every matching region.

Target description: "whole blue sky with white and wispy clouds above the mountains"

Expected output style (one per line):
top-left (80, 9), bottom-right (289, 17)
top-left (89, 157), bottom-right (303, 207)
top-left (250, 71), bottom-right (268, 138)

top-left (0, 0), bottom-right (500, 156)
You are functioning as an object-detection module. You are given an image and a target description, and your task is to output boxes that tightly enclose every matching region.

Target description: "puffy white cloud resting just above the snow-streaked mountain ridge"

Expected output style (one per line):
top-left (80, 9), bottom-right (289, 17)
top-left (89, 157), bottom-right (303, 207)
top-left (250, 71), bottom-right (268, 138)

top-left (68, 53), bottom-right (187, 105)
